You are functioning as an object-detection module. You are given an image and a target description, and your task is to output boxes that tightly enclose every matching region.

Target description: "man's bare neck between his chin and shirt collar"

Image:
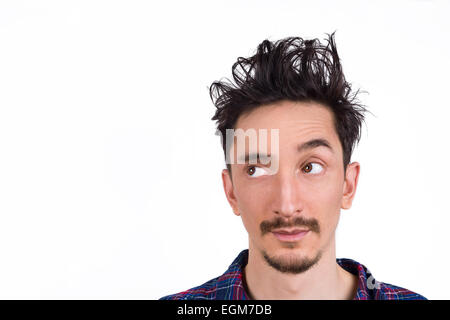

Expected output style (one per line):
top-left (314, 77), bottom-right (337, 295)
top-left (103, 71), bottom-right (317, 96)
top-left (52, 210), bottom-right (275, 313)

top-left (244, 239), bottom-right (358, 300)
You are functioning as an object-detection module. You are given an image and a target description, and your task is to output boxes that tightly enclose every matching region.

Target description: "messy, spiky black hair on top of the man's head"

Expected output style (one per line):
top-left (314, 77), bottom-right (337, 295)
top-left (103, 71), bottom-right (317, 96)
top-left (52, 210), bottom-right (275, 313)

top-left (209, 32), bottom-right (367, 176)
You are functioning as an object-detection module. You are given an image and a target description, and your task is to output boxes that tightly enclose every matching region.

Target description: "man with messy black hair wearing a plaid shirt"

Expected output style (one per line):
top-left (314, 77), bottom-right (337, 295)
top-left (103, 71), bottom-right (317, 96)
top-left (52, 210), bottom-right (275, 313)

top-left (161, 33), bottom-right (426, 300)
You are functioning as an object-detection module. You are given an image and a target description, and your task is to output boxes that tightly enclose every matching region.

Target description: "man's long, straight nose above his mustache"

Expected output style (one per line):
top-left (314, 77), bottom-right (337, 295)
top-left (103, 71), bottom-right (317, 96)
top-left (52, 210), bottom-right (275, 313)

top-left (273, 172), bottom-right (303, 219)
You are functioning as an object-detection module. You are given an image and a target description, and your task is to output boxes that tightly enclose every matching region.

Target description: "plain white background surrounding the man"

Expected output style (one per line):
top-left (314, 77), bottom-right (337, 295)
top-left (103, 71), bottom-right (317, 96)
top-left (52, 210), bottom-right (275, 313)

top-left (0, 0), bottom-right (450, 299)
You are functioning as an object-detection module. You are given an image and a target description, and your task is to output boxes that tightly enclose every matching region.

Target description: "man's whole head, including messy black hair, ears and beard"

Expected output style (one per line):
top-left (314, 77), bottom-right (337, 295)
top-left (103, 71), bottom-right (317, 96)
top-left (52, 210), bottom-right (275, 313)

top-left (210, 34), bottom-right (366, 273)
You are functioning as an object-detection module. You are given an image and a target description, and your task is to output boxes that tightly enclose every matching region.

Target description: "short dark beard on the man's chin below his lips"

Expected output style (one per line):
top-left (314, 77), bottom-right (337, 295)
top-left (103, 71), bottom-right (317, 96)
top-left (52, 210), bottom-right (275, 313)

top-left (262, 250), bottom-right (322, 274)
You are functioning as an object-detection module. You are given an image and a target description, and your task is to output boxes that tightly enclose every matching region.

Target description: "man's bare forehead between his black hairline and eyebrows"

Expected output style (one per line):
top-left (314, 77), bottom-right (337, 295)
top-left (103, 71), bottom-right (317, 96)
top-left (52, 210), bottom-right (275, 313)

top-left (235, 101), bottom-right (339, 144)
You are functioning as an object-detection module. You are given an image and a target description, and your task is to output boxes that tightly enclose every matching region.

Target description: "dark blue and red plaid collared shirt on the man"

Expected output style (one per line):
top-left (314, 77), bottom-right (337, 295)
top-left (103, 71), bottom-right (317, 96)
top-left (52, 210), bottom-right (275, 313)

top-left (160, 249), bottom-right (427, 300)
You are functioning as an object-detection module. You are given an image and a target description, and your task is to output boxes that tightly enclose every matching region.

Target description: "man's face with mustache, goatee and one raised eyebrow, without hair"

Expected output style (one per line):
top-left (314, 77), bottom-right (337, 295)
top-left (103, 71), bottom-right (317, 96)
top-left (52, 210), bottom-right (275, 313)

top-left (222, 101), bottom-right (359, 273)
